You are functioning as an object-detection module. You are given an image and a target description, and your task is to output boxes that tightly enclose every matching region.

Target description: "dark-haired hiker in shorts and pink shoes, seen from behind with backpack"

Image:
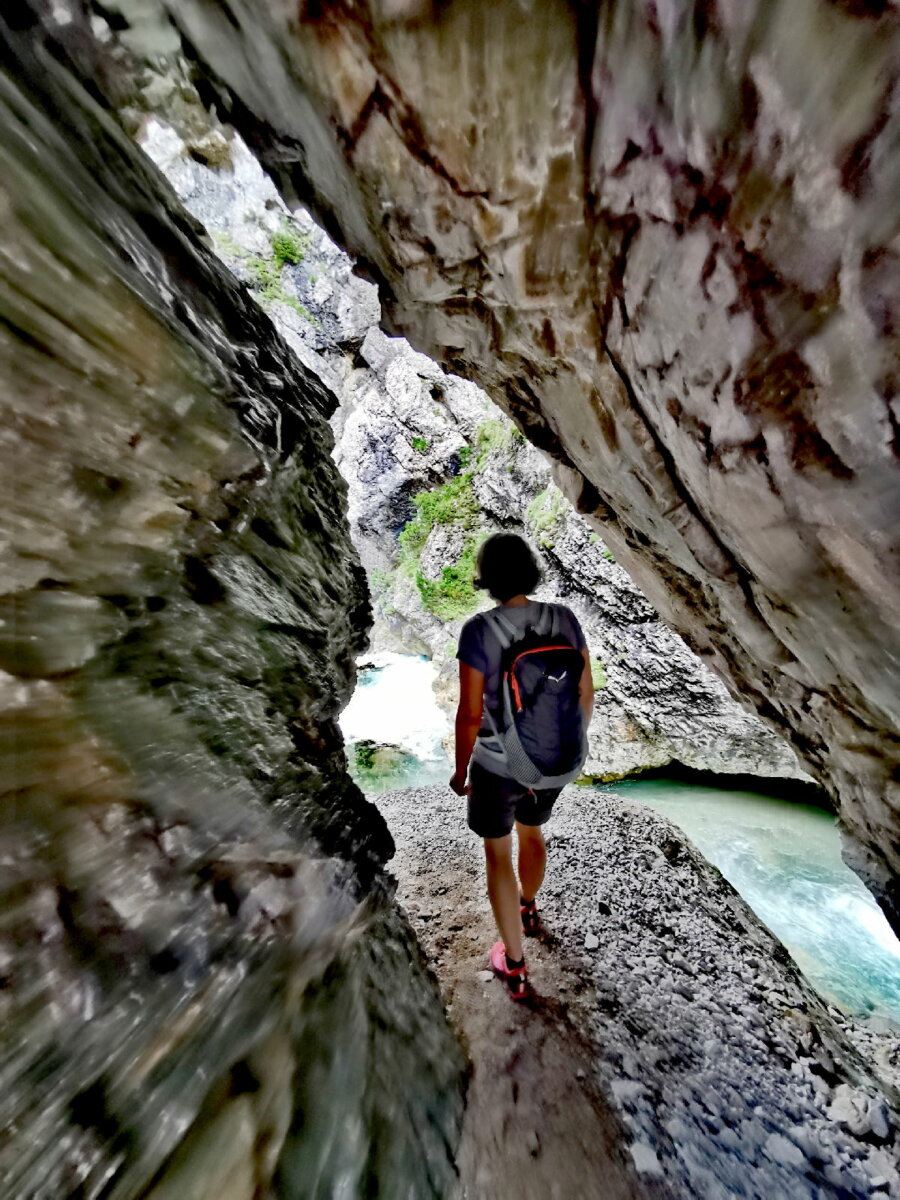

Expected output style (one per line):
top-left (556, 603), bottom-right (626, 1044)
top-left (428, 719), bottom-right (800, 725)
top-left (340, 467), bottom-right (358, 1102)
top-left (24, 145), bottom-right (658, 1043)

top-left (450, 533), bottom-right (594, 1000)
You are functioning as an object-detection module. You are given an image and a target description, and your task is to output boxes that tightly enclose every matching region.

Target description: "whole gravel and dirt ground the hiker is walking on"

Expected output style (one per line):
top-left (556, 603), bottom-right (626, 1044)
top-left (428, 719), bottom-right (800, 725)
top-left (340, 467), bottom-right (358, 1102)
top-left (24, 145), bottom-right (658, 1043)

top-left (372, 787), bottom-right (900, 1200)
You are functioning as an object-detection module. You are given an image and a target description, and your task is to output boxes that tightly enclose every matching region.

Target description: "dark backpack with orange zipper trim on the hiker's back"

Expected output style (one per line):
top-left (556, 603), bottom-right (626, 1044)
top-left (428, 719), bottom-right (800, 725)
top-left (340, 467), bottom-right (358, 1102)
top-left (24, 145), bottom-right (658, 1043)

top-left (479, 604), bottom-right (588, 788)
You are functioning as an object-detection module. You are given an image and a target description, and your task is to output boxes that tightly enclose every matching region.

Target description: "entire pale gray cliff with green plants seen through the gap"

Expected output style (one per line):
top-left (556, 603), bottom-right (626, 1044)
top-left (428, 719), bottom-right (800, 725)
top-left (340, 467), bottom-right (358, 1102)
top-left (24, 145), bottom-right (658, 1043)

top-left (138, 105), bottom-right (805, 780)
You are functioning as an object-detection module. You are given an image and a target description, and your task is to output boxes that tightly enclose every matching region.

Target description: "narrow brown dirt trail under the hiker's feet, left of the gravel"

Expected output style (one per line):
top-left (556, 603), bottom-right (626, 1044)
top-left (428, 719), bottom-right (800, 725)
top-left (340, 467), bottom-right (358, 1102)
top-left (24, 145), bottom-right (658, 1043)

top-left (374, 792), bottom-right (668, 1200)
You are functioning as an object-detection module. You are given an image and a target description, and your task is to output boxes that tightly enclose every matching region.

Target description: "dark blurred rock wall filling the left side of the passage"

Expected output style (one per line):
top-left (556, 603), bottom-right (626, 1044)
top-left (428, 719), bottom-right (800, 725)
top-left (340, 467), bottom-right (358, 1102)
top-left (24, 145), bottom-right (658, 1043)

top-left (0, 5), bottom-right (462, 1200)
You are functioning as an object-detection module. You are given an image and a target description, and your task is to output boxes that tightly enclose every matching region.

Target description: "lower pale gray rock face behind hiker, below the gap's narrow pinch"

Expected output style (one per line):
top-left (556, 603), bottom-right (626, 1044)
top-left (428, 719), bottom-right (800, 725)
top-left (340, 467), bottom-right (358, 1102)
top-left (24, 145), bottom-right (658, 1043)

top-left (336, 330), bottom-right (805, 780)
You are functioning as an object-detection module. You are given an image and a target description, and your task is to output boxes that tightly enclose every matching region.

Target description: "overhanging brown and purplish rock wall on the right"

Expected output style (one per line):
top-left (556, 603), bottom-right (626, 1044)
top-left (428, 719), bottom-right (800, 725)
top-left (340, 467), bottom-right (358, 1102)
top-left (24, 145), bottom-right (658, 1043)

top-left (157, 0), bottom-right (900, 924)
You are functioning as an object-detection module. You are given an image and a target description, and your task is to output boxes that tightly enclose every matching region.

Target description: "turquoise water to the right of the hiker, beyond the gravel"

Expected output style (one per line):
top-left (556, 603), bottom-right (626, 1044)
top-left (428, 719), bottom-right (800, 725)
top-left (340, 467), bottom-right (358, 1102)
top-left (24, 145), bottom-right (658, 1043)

top-left (600, 780), bottom-right (900, 1021)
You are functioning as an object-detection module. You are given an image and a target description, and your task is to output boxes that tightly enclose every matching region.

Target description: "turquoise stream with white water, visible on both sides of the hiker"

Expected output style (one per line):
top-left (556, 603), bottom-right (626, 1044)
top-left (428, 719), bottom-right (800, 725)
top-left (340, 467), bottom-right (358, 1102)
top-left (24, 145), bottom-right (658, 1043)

top-left (341, 654), bottom-right (900, 1021)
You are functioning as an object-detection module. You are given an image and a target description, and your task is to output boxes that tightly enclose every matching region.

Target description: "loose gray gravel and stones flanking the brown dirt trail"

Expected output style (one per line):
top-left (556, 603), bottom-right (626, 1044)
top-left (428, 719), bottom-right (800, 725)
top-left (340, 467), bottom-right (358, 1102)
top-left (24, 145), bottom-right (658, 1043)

top-left (377, 787), bottom-right (900, 1200)
